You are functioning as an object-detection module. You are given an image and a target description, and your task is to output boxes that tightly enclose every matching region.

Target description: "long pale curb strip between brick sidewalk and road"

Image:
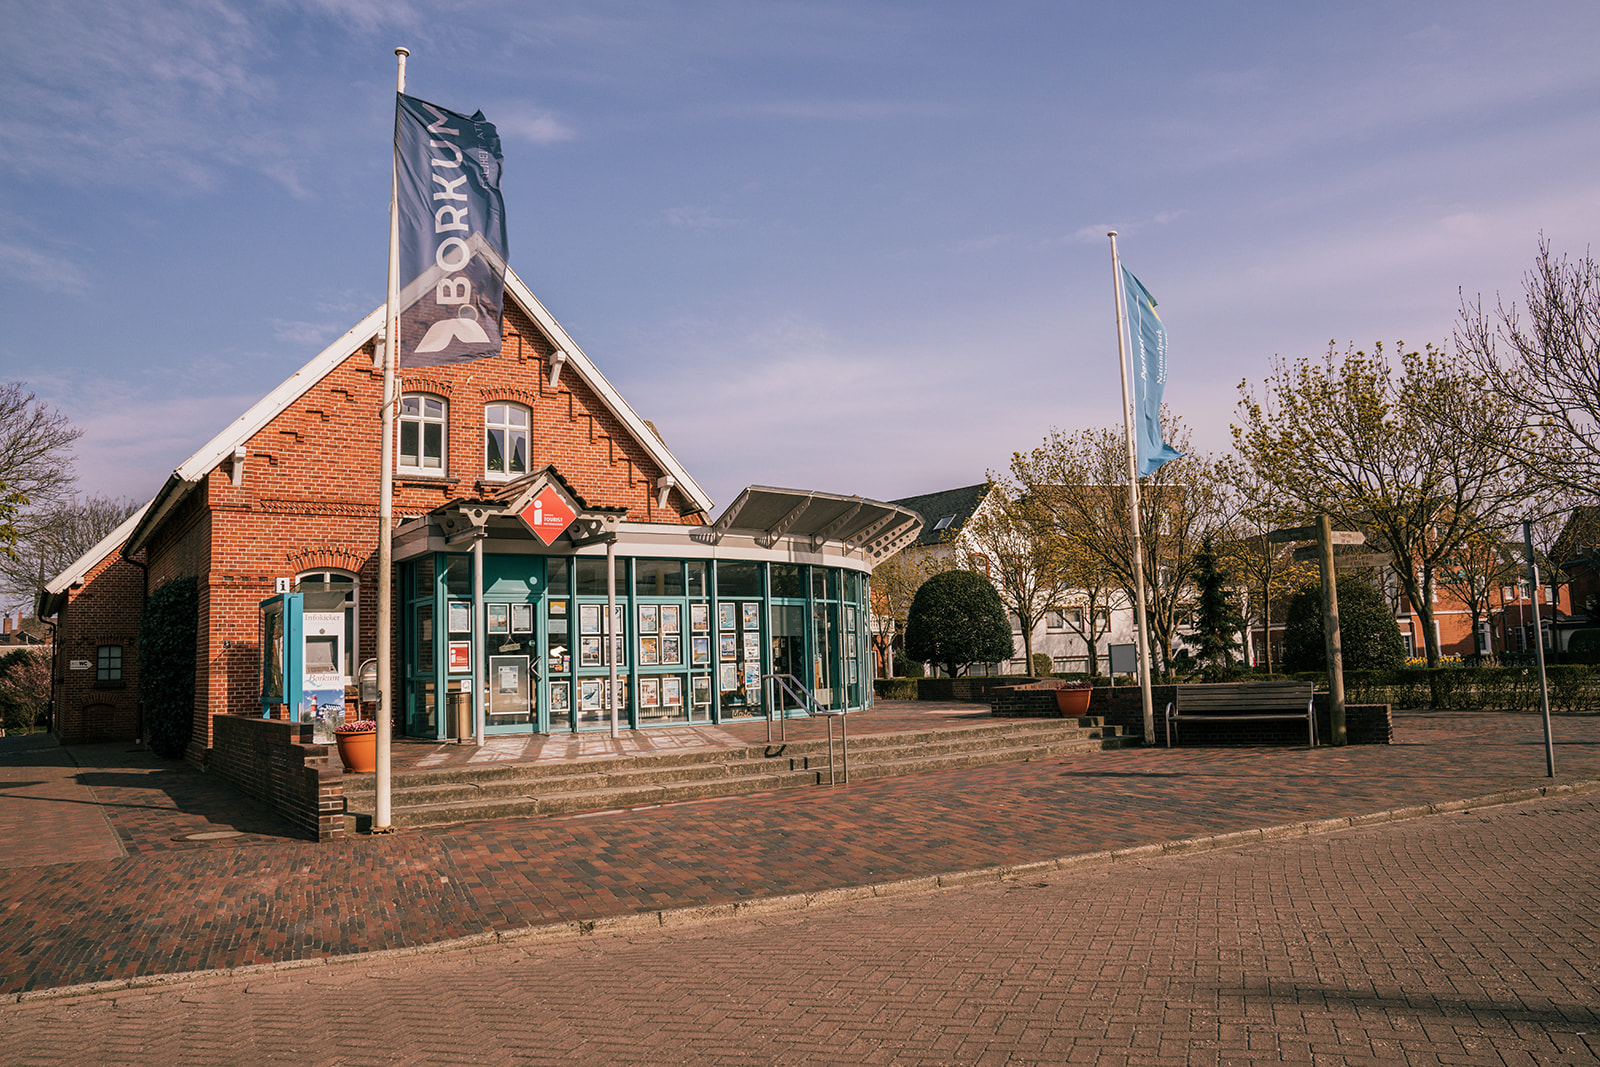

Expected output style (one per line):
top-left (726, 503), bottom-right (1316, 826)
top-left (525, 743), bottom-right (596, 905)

top-left (0, 779), bottom-right (1600, 1005)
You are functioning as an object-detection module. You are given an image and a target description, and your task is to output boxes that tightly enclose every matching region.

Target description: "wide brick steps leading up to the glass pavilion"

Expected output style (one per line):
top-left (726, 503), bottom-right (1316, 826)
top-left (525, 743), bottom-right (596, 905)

top-left (344, 718), bottom-right (1126, 829)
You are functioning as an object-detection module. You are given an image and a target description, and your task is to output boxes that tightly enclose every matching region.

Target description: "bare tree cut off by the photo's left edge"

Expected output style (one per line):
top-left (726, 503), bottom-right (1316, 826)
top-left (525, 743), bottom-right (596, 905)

top-left (0, 381), bottom-right (83, 606)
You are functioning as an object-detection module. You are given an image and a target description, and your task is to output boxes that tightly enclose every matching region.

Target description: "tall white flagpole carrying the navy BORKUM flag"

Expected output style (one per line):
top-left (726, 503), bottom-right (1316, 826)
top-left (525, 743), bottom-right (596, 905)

top-left (373, 48), bottom-right (411, 833)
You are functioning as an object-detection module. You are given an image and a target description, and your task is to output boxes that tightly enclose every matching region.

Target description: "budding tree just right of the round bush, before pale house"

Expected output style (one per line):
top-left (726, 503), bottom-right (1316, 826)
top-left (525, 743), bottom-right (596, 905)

top-left (962, 480), bottom-right (1066, 664)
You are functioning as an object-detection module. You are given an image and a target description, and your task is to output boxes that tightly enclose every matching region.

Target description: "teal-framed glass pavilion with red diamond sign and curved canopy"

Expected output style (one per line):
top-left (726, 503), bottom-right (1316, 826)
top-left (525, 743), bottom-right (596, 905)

top-left (394, 467), bottom-right (922, 739)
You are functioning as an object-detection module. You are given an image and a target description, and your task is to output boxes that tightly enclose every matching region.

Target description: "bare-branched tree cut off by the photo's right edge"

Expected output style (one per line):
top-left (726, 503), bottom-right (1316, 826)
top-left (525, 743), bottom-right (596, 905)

top-left (1456, 235), bottom-right (1600, 498)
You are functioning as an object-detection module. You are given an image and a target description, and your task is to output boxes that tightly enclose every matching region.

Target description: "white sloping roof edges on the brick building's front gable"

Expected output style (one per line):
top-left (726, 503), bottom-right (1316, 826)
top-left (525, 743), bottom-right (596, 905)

top-left (125, 269), bottom-right (712, 553)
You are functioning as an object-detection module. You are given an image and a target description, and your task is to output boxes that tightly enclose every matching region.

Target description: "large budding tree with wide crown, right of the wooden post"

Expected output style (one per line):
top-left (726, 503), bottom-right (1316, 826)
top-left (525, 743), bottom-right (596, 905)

top-left (1234, 344), bottom-right (1523, 667)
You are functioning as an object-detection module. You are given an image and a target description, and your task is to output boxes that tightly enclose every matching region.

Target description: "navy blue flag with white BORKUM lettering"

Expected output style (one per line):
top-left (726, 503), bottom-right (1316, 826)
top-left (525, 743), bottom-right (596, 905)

top-left (395, 93), bottom-right (506, 366)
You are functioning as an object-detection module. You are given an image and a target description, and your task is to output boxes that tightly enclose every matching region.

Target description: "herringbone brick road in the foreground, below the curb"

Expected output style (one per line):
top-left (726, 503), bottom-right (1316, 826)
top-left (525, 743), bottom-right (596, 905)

top-left (0, 780), bottom-right (1600, 1065)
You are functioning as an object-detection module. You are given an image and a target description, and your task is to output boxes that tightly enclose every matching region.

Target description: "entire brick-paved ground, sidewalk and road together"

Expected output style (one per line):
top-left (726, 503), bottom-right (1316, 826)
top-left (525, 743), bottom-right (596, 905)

top-left (0, 703), bottom-right (1600, 1064)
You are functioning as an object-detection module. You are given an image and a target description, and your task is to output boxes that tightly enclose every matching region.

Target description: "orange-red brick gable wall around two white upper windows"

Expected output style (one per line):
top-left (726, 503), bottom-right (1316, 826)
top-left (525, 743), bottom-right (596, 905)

top-left (112, 292), bottom-right (704, 763)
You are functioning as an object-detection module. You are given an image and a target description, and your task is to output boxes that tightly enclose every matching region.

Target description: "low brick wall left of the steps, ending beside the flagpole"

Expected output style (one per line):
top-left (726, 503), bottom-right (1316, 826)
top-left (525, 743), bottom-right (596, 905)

top-left (206, 715), bottom-right (344, 841)
